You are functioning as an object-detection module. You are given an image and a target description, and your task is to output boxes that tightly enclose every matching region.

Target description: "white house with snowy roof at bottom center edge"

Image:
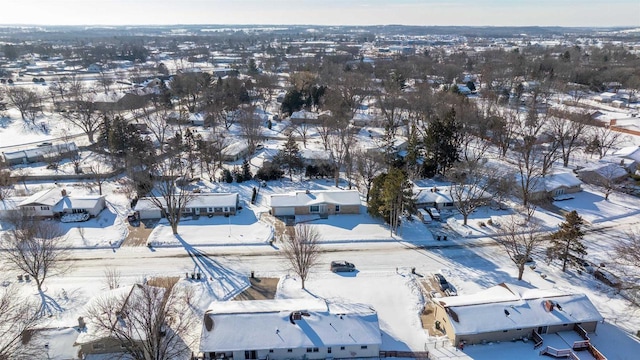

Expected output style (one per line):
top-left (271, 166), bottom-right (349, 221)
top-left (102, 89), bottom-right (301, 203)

top-left (200, 299), bottom-right (382, 360)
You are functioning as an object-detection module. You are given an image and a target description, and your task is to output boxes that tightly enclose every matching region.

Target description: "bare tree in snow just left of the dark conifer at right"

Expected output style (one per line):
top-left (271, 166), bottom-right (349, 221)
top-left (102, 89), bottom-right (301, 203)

top-left (495, 215), bottom-right (544, 280)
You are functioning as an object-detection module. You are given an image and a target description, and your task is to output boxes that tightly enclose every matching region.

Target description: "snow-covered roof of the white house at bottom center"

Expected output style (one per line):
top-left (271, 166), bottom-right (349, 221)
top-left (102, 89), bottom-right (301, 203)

top-left (200, 299), bottom-right (382, 352)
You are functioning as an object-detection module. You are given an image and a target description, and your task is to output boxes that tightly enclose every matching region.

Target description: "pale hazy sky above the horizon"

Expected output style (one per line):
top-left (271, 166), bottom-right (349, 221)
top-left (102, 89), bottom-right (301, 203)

top-left (0, 0), bottom-right (640, 27)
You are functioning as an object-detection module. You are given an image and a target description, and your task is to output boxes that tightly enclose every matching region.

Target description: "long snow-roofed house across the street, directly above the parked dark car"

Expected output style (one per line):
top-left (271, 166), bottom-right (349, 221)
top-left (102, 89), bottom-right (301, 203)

top-left (270, 190), bottom-right (361, 216)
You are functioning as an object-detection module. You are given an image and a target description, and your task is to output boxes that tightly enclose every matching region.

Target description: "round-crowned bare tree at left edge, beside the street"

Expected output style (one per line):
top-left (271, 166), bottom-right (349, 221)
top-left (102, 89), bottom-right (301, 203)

top-left (0, 210), bottom-right (69, 292)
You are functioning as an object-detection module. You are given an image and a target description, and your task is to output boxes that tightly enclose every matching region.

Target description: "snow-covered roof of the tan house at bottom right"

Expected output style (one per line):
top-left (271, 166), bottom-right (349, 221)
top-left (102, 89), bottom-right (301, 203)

top-left (437, 283), bottom-right (603, 335)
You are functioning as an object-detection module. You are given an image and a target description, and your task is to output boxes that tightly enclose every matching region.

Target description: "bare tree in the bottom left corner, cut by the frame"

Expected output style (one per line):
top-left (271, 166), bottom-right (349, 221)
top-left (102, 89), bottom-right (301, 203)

top-left (0, 288), bottom-right (42, 359)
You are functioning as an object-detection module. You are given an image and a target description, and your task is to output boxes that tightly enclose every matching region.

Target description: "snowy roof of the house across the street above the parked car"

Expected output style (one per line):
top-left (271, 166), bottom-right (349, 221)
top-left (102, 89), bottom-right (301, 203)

top-left (271, 190), bottom-right (360, 207)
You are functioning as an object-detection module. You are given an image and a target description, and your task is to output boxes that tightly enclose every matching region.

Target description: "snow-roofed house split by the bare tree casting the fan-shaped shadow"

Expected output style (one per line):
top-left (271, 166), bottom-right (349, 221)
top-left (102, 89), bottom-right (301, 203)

top-left (133, 193), bottom-right (240, 220)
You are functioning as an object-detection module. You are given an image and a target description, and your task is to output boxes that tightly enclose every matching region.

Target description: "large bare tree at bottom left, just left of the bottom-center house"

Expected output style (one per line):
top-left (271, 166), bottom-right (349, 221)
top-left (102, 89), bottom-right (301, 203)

top-left (87, 278), bottom-right (195, 360)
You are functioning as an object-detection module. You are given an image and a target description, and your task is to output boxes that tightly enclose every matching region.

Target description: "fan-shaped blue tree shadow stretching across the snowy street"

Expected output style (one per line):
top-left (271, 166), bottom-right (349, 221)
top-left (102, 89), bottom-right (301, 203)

top-left (176, 235), bottom-right (249, 300)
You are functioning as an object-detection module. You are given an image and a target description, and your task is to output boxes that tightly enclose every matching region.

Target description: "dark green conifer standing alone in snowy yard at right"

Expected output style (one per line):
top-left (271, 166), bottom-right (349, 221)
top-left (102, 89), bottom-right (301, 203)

top-left (547, 210), bottom-right (587, 271)
